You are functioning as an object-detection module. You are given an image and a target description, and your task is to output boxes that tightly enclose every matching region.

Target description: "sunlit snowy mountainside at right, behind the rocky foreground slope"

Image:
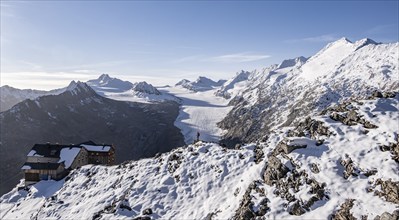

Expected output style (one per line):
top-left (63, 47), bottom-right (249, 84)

top-left (219, 38), bottom-right (399, 146)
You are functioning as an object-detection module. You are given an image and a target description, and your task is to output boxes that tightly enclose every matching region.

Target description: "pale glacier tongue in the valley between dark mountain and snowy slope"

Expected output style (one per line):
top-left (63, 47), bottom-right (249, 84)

top-left (158, 87), bottom-right (232, 144)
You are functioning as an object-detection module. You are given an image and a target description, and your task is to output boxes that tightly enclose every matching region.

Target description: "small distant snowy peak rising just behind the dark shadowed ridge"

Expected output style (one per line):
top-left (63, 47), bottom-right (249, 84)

top-left (87, 74), bottom-right (133, 95)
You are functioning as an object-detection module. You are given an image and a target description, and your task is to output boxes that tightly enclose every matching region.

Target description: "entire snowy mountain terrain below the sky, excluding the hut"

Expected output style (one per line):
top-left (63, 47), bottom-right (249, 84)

top-left (0, 38), bottom-right (399, 219)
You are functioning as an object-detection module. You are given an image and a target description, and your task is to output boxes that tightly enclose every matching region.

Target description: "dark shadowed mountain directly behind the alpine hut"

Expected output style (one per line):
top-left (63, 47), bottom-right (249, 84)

top-left (0, 82), bottom-right (184, 196)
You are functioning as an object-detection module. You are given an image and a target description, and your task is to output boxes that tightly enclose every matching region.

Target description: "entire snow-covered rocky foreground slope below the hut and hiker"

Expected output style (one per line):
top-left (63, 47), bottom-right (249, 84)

top-left (0, 93), bottom-right (399, 219)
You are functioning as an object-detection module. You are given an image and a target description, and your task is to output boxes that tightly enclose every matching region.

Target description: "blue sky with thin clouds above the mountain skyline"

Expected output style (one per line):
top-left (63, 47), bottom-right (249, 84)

top-left (1, 0), bottom-right (399, 89)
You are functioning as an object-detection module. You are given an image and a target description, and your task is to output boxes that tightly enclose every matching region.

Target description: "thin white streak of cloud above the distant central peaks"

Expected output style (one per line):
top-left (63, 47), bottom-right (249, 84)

top-left (207, 53), bottom-right (271, 63)
